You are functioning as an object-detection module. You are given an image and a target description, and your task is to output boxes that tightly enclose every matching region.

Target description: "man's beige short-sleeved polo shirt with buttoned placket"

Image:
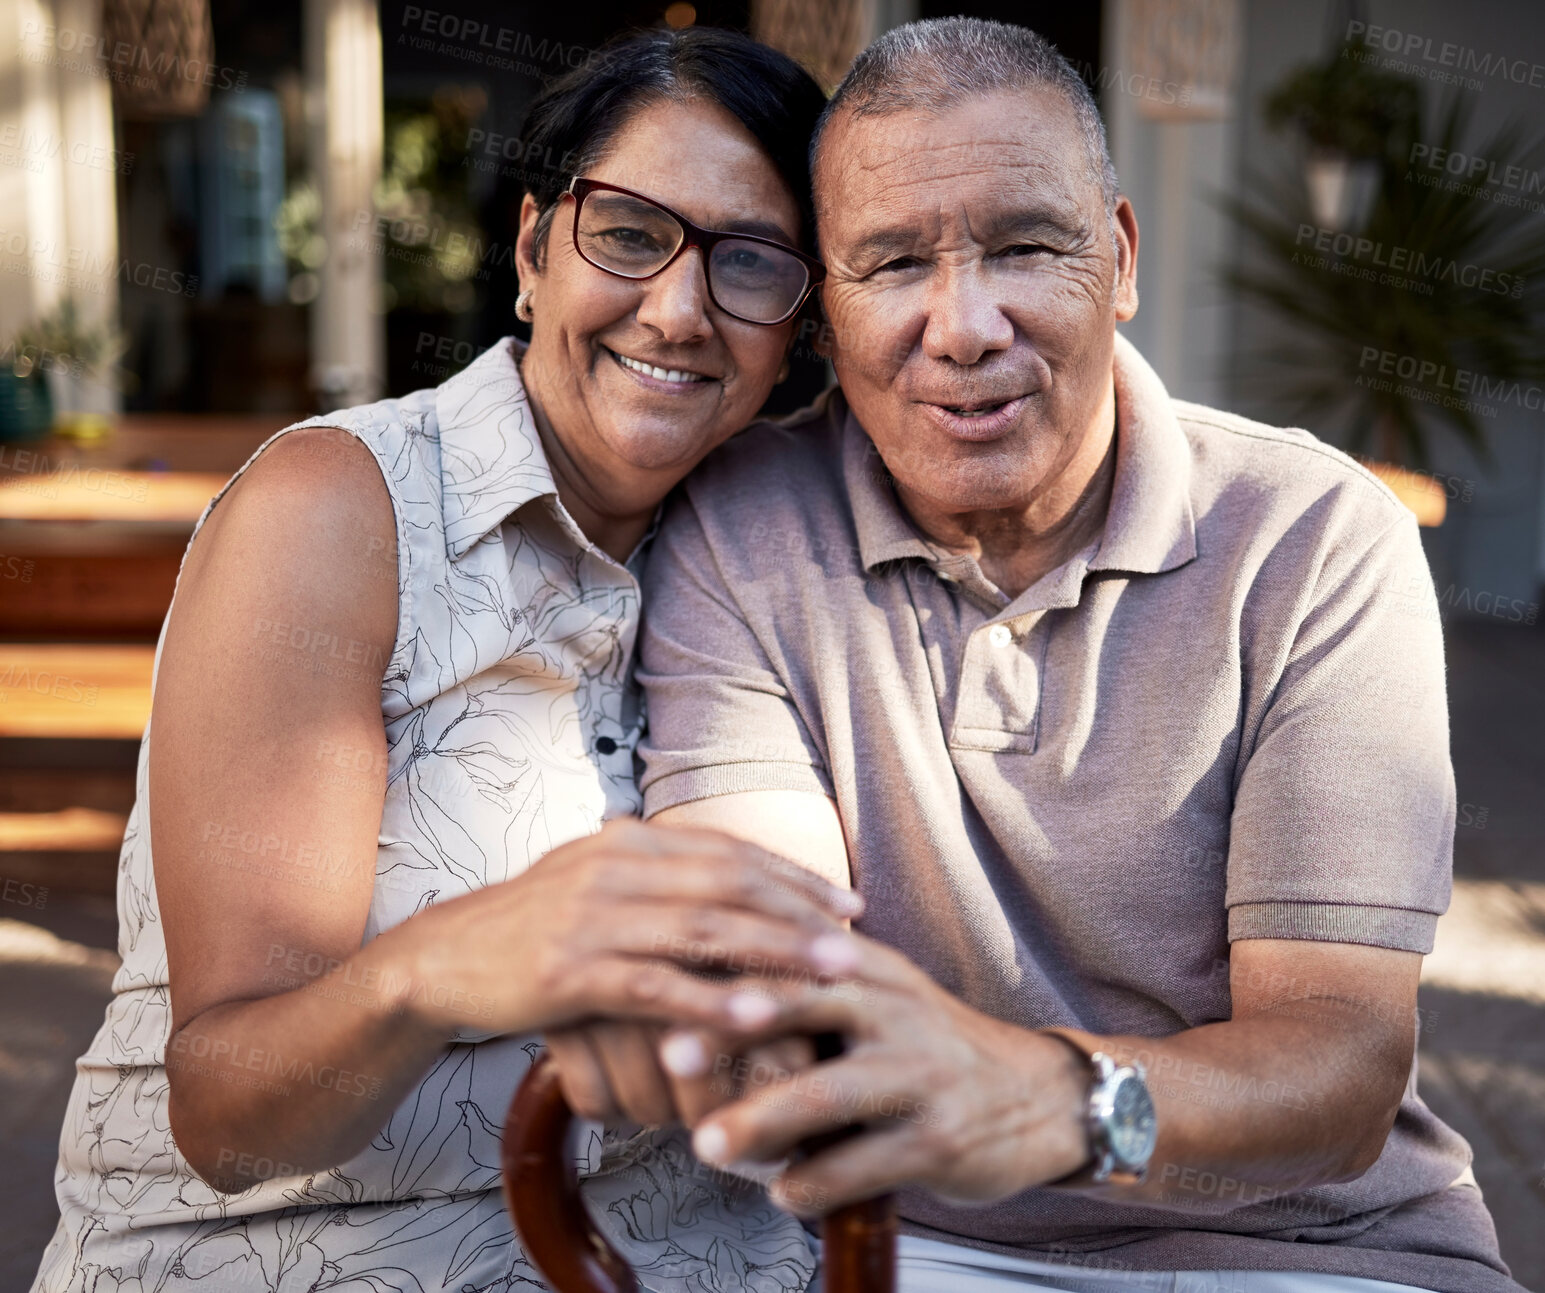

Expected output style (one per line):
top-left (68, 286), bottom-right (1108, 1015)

top-left (640, 338), bottom-right (1516, 1293)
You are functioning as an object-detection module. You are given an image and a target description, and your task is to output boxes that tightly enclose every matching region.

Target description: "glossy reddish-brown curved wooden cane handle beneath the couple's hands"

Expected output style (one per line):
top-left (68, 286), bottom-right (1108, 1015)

top-left (502, 1055), bottom-right (896, 1293)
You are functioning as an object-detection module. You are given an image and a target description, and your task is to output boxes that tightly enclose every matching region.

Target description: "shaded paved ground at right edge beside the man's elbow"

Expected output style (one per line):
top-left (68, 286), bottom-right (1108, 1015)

top-left (1420, 624), bottom-right (1545, 1290)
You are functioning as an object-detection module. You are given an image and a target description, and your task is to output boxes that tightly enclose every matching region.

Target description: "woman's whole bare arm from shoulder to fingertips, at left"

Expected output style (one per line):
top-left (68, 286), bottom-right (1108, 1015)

top-left (150, 447), bottom-right (859, 1189)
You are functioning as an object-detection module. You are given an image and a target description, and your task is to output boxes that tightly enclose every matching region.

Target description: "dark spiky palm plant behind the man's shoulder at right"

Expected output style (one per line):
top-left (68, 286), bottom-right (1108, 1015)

top-left (1225, 55), bottom-right (1545, 524)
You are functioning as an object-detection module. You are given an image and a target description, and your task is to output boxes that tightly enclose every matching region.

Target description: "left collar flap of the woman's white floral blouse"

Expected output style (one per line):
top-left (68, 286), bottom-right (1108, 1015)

top-left (434, 337), bottom-right (558, 559)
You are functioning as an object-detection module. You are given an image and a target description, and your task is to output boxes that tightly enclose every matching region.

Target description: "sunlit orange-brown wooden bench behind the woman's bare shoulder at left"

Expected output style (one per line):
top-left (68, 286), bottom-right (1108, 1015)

top-left (0, 414), bottom-right (281, 894)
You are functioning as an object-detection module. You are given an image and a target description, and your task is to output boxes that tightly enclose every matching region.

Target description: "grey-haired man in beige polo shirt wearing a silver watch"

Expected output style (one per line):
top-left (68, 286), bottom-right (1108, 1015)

top-left (568, 19), bottom-right (1517, 1293)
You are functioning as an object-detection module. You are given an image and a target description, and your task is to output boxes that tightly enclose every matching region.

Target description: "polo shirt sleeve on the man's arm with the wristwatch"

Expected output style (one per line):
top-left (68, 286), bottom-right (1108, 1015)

top-left (1227, 503), bottom-right (1454, 953)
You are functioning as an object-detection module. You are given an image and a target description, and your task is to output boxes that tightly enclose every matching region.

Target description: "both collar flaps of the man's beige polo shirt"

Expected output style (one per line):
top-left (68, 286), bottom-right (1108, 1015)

top-left (833, 334), bottom-right (1196, 575)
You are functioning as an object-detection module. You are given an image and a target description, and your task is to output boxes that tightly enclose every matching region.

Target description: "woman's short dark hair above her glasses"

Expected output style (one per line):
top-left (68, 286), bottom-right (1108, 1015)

top-left (519, 26), bottom-right (827, 264)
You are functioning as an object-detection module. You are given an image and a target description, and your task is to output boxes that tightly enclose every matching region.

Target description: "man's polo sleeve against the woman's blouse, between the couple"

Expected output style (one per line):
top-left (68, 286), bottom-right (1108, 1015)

top-left (638, 491), bottom-right (833, 817)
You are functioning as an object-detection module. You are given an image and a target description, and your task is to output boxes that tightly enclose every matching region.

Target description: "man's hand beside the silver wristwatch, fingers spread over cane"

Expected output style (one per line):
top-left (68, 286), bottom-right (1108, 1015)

top-left (664, 935), bottom-right (1088, 1211)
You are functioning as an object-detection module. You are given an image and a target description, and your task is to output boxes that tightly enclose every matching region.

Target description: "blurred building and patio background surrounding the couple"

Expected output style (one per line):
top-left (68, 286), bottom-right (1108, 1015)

top-left (0, 0), bottom-right (1545, 1290)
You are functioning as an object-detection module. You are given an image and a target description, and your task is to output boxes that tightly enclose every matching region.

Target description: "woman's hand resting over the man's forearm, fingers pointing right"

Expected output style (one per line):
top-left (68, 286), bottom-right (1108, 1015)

top-left (377, 819), bottom-right (859, 1044)
